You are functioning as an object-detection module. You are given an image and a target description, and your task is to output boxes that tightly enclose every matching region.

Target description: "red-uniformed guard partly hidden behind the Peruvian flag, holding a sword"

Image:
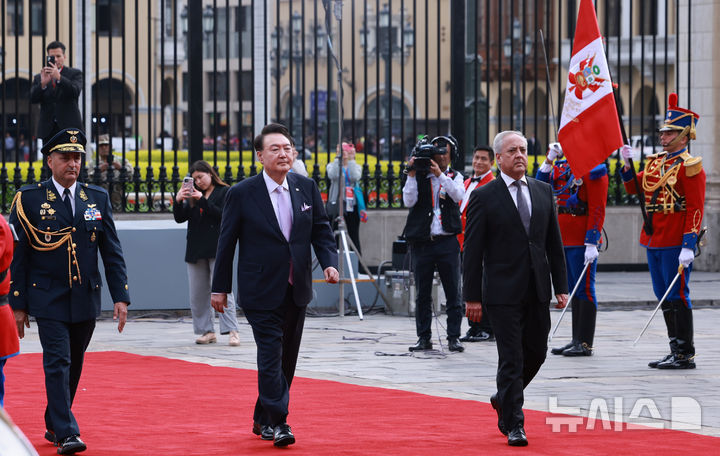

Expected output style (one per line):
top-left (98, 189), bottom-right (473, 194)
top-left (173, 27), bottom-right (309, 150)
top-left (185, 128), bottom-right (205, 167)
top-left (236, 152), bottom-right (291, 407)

top-left (536, 143), bottom-right (608, 356)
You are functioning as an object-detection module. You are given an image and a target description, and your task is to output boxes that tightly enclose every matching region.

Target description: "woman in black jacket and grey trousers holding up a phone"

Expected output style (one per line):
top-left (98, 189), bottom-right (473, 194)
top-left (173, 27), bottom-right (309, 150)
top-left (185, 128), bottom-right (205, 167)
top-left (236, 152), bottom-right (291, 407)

top-left (173, 160), bottom-right (240, 347)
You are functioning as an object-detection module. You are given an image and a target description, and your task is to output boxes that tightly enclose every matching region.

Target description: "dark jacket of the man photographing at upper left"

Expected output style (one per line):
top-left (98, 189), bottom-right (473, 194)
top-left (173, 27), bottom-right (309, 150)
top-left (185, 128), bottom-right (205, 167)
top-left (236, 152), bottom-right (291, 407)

top-left (30, 66), bottom-right (83, 140)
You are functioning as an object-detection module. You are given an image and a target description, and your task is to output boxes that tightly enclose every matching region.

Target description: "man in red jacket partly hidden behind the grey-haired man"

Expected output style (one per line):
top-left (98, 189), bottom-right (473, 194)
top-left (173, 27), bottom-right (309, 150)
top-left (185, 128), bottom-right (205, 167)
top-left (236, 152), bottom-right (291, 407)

top-left (458, 146), bottom-right (495, 342)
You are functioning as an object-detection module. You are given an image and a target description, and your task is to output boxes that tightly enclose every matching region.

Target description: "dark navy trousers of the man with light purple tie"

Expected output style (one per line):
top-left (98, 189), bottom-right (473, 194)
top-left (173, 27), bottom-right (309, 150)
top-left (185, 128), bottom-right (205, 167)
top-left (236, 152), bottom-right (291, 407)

top-left (243, 284), bottom-right (306, 426)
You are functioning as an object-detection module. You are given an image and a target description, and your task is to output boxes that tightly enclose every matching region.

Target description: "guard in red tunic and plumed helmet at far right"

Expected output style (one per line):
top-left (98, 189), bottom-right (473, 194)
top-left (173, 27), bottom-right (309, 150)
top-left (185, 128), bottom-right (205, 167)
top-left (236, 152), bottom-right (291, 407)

top-left (621, 93), bottom-right (705, 369)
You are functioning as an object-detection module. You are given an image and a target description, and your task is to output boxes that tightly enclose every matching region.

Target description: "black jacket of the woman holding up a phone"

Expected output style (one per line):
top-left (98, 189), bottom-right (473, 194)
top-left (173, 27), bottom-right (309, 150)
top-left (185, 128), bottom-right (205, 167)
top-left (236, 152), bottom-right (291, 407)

top-left (173, 186), bottom-right (230, 263)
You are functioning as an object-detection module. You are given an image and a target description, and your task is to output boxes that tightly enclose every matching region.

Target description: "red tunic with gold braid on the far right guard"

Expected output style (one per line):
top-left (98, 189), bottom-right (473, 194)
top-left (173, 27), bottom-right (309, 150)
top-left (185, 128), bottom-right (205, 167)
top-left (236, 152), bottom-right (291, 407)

top-left (623, 150), bottom-right (705, 249)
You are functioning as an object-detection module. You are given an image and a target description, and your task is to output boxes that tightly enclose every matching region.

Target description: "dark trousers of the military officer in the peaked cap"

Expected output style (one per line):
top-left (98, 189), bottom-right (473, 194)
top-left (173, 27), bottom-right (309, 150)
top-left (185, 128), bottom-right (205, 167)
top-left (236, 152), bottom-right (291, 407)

top-left (36, 318), bottom-right (95, 440)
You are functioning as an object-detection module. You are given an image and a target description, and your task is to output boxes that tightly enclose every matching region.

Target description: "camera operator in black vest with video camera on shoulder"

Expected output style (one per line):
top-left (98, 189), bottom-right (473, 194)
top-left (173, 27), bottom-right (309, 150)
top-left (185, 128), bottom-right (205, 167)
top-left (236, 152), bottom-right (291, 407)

top-left (403, 136), bottom-right (465, 352)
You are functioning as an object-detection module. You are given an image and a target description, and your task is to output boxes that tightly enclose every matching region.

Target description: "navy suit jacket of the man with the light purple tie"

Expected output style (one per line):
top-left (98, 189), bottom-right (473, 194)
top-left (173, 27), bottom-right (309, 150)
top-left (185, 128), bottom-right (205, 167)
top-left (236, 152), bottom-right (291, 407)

top-left (212, 173), bottom-right (337, 310)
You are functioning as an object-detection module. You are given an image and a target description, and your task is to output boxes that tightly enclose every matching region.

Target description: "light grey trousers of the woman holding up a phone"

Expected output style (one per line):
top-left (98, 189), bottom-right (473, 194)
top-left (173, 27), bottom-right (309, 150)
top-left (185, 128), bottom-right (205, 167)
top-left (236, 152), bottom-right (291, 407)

top-left (185, 258), bottom-right (238, 335)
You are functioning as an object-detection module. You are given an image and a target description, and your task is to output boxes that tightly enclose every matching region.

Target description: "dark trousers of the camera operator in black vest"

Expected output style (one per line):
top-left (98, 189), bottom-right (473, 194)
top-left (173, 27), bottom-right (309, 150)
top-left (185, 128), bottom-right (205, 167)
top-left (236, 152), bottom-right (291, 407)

top-left (412, 236), bottom-right (463, 339)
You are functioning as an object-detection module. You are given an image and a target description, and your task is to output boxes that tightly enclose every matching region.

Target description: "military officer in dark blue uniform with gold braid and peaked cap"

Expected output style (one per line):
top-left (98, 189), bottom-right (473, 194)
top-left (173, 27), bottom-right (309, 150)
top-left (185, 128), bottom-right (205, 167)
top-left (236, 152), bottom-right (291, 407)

top-left (9, 128), bottom-right (130, 454)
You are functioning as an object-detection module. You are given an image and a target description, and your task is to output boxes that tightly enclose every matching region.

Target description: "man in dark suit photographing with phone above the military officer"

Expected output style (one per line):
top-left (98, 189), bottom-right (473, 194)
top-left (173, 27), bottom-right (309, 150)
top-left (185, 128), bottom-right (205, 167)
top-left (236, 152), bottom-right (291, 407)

top-left (30, 41), bottom-right (83, 143)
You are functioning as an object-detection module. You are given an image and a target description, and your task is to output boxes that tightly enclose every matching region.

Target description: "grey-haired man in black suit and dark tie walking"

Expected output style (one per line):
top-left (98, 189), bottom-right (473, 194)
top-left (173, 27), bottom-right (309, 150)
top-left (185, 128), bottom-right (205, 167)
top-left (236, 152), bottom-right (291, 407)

top-left (463, 131), bottom-right (568, 446)
